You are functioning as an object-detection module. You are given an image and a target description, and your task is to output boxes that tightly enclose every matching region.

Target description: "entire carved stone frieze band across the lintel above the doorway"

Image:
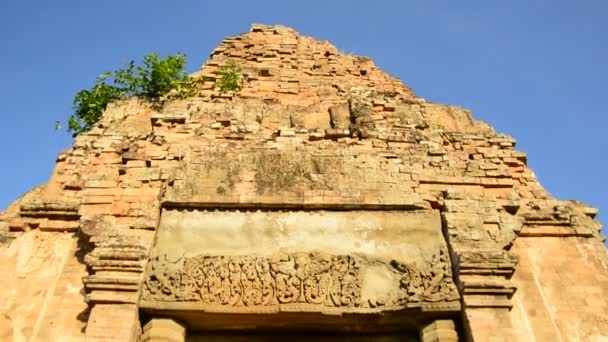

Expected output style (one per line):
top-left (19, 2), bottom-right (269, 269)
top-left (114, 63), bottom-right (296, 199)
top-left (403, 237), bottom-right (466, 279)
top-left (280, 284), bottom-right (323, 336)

top-left (142, 250), bottom-right (459, 310)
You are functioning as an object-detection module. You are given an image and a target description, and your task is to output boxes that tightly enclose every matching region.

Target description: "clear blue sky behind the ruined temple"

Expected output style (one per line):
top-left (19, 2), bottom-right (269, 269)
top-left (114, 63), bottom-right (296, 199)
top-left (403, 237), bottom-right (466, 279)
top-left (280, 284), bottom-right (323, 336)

top-left (0, 0), bottom-right (608, 238)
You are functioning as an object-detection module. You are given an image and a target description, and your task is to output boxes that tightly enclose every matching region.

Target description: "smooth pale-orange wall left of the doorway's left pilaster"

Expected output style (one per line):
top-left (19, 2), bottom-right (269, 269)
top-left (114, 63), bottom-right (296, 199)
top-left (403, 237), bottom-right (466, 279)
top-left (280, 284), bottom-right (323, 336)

top-left (0, 230), bottom-right (88, 341)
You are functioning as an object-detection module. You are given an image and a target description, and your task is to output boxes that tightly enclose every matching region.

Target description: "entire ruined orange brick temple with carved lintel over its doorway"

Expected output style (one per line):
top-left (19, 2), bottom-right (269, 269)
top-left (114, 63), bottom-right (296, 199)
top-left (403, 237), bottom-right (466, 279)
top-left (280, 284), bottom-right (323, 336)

top-left (0, 25), bottom-right (608, 342)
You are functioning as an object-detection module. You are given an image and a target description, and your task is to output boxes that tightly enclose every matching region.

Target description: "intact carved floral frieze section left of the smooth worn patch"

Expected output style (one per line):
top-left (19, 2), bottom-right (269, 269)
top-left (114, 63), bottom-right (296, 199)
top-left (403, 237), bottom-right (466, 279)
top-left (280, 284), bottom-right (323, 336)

top-left (144, 253), bottom-right (360, 306)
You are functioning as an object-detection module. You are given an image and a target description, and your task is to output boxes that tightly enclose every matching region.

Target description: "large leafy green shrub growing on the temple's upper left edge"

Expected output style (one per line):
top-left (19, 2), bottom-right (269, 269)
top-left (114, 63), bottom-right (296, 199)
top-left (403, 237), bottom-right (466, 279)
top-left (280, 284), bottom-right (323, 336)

top-left (66, 52), bottom-right (196, 135)
